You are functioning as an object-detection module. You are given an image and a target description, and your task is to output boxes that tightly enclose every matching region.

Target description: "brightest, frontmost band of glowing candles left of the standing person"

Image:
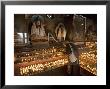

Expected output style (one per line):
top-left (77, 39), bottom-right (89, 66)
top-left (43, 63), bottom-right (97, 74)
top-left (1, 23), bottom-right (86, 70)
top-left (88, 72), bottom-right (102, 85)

top-left (20, 57), bottom-right (68, 75)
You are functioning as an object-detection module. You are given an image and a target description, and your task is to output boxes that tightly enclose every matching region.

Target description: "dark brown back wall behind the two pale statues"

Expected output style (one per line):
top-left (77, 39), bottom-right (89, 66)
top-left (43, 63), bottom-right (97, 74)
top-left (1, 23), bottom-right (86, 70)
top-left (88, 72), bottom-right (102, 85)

top-left (14, 14), bottom-right (97, 41)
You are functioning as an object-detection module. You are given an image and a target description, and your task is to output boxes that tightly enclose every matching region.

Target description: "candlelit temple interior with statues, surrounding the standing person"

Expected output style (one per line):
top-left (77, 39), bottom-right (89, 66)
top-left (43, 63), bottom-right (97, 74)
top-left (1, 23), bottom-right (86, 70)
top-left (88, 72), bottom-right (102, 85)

top-left (14, 14), bottom-right (97, 76)
